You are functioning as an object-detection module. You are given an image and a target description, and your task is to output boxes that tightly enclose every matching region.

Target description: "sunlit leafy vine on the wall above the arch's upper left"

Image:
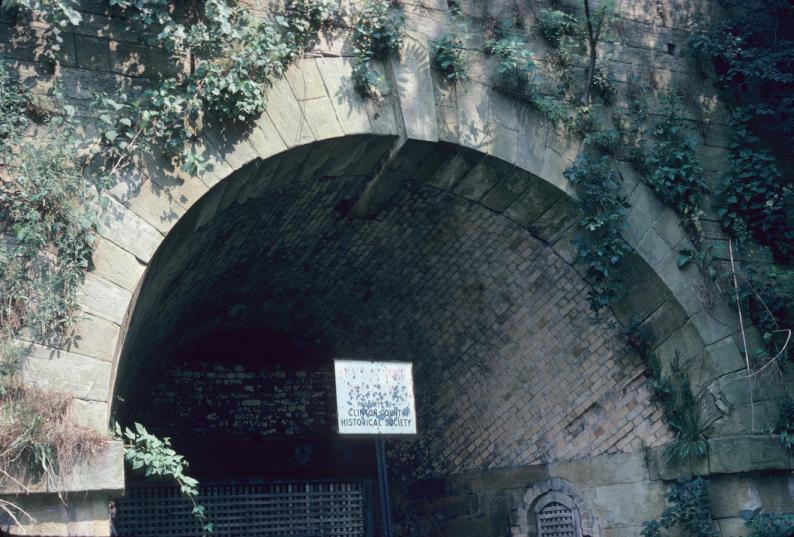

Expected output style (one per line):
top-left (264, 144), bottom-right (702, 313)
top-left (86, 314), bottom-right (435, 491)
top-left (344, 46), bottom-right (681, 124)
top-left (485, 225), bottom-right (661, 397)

top-left (92, 0), bottom-right (333, 177)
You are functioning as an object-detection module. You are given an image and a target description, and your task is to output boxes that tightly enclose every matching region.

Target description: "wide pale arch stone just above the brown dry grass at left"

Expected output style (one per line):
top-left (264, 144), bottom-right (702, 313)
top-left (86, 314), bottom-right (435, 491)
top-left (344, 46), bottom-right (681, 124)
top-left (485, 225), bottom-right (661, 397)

top-left (22, 344), bottom-right (111, 401)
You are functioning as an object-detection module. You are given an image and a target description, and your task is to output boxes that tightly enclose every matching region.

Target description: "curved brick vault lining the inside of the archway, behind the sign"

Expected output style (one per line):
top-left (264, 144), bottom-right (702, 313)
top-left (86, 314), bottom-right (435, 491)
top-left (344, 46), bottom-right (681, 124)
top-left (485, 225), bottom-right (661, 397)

top-left (114, 139), bottom-right (669, 478)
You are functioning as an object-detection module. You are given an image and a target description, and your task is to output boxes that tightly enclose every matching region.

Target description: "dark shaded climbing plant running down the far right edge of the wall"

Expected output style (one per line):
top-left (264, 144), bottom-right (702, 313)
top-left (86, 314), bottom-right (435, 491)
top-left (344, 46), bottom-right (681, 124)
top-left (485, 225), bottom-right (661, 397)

top-left (689, 0), bottom-right (794, 402)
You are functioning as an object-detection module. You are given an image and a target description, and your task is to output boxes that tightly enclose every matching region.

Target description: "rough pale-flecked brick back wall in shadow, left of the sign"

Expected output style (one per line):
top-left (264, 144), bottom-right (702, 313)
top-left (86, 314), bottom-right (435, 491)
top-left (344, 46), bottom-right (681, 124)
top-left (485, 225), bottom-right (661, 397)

top-left (139, 361), bottom-right (335, 440)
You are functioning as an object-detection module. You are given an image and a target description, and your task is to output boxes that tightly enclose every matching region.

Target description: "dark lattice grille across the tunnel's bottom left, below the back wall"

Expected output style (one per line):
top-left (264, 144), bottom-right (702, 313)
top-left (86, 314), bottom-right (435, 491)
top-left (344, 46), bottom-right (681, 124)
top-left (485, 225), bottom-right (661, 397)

top-left (115, 481), bottom-right (368, 537)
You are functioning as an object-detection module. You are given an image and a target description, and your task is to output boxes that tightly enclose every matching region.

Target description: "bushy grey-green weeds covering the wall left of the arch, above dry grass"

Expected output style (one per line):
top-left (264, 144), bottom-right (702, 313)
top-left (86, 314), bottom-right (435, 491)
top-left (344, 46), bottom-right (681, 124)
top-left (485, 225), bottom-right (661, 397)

top-left (0, 67), bottom-right (98, 345)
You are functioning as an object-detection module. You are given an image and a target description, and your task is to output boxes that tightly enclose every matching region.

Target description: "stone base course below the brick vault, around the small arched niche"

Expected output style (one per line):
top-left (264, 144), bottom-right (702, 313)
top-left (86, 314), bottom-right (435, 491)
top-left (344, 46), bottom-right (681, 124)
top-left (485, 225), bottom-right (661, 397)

top-left (394, 448), bottom-right (794, 537)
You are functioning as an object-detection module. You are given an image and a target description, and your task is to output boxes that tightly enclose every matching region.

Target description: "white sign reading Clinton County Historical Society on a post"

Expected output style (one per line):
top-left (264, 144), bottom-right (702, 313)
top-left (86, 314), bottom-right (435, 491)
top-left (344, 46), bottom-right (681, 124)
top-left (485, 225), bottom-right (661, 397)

top-left (334, 360), bottom-right (416, 434)
